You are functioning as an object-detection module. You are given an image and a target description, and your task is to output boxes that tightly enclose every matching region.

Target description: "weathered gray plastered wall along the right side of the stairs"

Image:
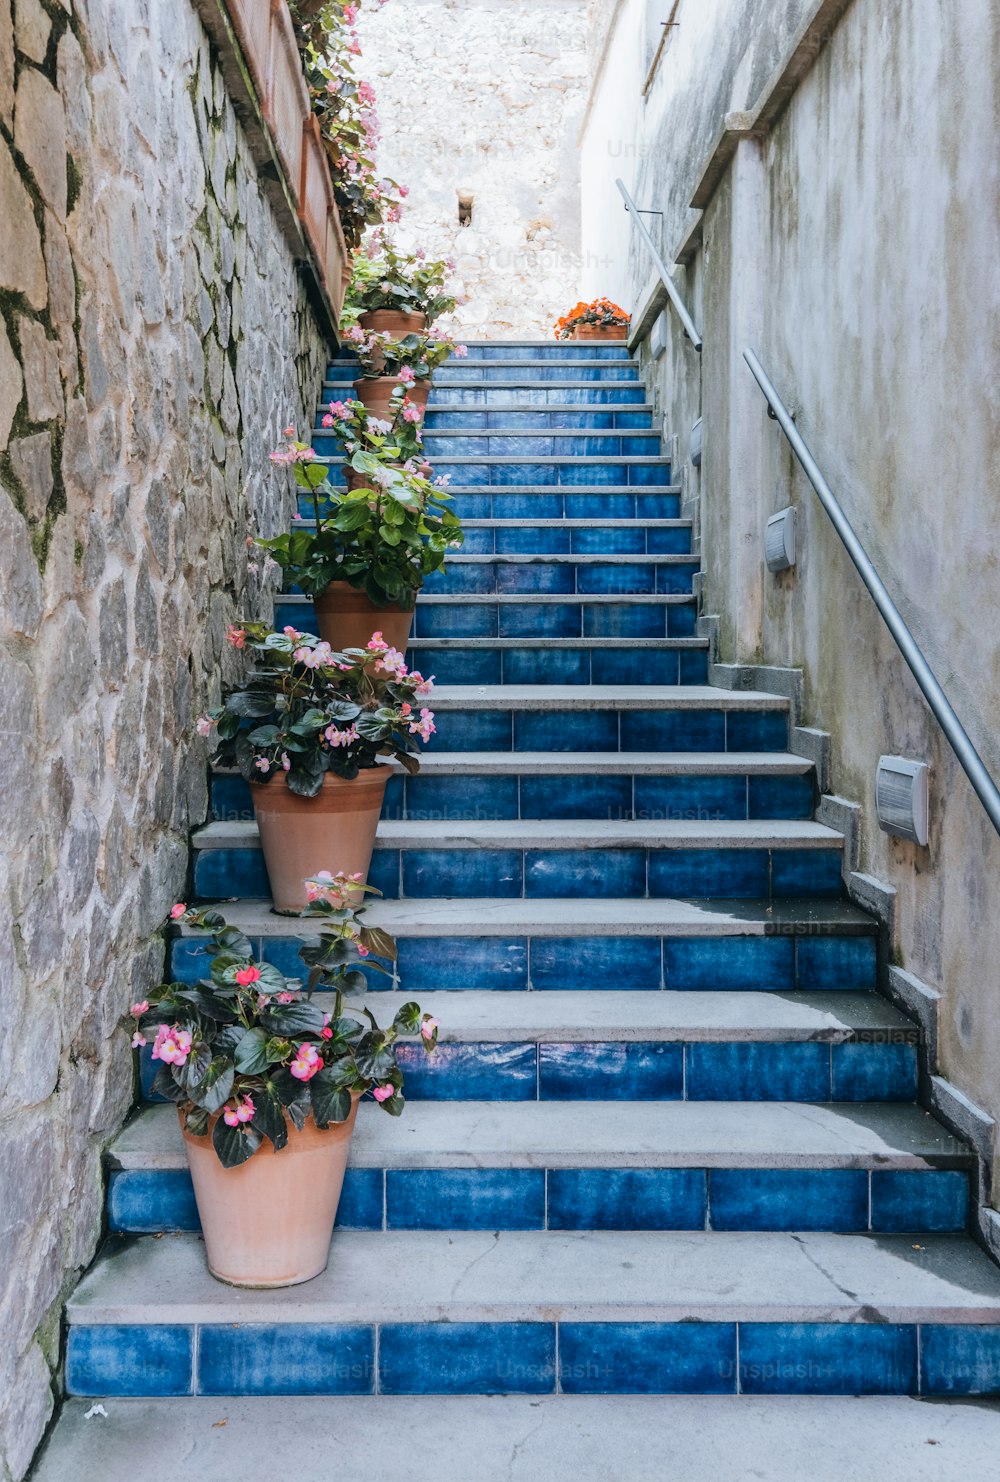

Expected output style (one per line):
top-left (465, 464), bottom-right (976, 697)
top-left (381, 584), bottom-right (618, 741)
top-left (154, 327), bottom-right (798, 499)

top-left (585, 0), bottom-right (1000, 1202)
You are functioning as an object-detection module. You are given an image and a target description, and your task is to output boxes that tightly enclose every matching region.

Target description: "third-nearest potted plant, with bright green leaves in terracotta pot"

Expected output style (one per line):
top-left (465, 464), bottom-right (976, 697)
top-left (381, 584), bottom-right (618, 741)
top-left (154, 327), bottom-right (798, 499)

top-left (261, 417), bottom-right (464, 651)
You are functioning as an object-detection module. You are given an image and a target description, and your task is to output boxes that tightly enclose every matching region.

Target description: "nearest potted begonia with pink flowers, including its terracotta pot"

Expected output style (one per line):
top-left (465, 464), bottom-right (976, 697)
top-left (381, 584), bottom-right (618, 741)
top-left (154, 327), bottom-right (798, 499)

top-left (129, 871), bottom-right (437, 1286)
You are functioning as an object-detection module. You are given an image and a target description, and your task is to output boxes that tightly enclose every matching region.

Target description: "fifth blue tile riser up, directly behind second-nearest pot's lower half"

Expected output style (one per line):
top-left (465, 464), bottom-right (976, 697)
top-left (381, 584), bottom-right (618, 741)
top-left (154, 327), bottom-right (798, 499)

top-left (194, 846), bottom-right (843, 901)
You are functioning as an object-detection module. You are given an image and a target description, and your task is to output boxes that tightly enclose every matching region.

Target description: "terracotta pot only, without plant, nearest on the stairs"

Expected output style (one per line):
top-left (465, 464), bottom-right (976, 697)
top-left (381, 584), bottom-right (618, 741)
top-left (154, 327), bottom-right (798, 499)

top-left (181, 1095), bottom-right (360, 1286)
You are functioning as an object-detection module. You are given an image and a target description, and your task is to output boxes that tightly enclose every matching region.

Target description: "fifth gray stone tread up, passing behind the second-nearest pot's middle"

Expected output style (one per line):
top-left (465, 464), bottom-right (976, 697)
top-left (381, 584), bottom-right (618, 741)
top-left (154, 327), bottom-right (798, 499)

top-left (191, 818), bottom-right (843, 849)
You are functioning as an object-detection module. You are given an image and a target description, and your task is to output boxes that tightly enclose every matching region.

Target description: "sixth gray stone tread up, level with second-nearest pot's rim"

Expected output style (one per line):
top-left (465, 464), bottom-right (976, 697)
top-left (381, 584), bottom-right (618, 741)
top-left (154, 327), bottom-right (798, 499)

top-left (216, 746), bottom-right (813, 777)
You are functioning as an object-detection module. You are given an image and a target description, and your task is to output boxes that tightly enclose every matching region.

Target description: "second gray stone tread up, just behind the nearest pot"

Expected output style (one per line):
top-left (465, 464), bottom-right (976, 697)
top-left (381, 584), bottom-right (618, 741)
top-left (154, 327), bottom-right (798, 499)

top-left (108, 1101), bottom-right (969, 1171)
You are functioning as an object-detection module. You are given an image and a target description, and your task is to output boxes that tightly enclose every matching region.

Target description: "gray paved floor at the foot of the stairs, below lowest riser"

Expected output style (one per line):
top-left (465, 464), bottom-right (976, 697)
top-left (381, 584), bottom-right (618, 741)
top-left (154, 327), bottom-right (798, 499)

top-left (33, 1395), bottom-right (1000, 1482)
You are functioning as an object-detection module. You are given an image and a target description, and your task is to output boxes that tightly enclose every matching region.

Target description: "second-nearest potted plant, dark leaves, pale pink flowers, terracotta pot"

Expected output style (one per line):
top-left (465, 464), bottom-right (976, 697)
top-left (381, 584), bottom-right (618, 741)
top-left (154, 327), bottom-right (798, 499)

top-left (199, 624), bottom-right (434, 916)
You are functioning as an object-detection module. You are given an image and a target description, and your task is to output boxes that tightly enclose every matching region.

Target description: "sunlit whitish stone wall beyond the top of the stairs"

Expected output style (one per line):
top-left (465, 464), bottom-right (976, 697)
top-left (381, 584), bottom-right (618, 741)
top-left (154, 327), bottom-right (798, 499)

top-left (359, 0), bottom-right (587, 339)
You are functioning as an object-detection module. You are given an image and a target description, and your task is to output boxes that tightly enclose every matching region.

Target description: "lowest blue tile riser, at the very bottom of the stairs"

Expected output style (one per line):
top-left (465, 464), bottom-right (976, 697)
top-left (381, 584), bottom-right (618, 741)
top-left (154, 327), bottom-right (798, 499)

top-left (67, 1322), bottom-right (1000, 1398)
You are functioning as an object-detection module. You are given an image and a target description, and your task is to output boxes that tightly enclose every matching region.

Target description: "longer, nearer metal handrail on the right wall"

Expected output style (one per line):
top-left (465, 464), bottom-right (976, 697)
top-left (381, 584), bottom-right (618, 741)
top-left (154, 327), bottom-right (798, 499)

top-left (744, 350), bottom-right (1000, 834)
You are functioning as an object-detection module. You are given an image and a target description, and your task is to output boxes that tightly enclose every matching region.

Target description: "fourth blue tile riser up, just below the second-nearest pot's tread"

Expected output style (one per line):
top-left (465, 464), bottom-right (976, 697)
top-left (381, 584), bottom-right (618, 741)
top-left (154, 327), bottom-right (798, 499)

top-left (170, 920), bottom-right (877, 989)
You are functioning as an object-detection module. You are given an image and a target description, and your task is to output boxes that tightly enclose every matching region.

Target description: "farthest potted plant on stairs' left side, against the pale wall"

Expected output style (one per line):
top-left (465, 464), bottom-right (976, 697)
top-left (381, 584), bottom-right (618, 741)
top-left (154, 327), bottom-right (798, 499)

top-left (345, 233), bottom-right (456, 338)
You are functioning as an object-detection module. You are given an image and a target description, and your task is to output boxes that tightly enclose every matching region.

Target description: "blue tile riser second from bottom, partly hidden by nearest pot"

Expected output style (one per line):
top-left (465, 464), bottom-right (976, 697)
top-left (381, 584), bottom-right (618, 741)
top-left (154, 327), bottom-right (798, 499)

top-left (108, 1166), bottom-right (969, 1235)
